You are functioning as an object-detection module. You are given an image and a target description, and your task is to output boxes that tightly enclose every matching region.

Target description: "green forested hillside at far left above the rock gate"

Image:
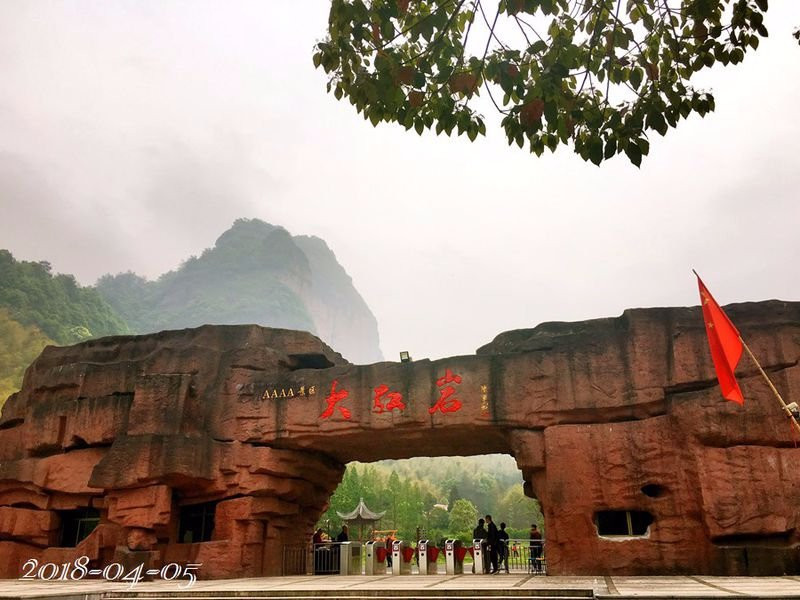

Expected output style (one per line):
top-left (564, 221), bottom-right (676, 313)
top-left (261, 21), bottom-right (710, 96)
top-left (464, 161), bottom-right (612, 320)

top-left (0, 250), bottom-right (128, 405)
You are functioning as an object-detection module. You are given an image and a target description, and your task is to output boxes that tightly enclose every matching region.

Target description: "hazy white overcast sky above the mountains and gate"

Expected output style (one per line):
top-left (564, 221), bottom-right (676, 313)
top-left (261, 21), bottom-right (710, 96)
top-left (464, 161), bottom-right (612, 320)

top-left (0, 0), bottom-right (800, 360)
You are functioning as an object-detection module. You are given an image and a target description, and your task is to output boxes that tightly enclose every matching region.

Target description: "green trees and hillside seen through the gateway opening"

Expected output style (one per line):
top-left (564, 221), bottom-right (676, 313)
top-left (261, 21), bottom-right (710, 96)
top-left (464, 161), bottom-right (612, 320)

top-left (319, 454), bottom-right (543, 543)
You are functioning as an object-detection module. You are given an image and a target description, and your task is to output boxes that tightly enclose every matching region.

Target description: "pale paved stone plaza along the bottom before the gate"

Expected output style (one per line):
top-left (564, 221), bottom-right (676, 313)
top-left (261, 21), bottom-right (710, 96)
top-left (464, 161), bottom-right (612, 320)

top-left (0, 575), bottom-right (800, 600)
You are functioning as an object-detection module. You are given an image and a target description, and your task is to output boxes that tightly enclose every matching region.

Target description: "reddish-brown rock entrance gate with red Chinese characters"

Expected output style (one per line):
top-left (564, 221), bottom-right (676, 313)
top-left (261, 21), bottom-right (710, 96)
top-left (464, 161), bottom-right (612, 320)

top-left (0, 301), bottom-right (800, 578)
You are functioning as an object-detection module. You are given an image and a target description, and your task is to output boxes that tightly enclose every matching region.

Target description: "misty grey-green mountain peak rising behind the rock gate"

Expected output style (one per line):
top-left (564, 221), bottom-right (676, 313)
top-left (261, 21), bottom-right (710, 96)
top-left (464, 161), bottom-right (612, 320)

top-left (97, 219), bottom-right (383, 363)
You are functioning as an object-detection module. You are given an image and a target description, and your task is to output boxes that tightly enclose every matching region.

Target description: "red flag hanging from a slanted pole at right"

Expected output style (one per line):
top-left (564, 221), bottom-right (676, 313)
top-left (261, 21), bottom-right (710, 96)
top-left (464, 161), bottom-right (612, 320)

top-left (695, 273), bottom-right (744, 404)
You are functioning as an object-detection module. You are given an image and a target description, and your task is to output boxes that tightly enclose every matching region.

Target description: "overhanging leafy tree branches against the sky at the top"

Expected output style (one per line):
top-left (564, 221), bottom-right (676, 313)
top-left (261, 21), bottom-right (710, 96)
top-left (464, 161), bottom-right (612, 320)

top-left (314, 0), bottom-right (772, 166)
